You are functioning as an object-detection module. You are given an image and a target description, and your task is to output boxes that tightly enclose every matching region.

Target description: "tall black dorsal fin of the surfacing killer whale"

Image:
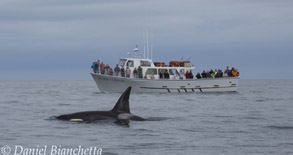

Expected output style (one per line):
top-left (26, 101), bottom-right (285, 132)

top-left (112, 87), bottom-right (131, 113)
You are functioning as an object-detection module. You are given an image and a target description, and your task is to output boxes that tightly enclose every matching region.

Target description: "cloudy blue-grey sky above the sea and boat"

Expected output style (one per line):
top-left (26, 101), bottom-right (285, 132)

top-left (0, 0), bottom-right (293, 80)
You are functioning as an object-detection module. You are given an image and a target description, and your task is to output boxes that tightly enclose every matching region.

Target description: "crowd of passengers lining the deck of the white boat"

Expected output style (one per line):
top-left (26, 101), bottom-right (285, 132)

top-left (92, 60), bottom-right (239, 79)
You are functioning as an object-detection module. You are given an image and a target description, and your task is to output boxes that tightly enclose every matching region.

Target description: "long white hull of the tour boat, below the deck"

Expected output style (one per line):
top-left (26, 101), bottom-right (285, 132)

top-left (91, 73), bottom-right (239, 93)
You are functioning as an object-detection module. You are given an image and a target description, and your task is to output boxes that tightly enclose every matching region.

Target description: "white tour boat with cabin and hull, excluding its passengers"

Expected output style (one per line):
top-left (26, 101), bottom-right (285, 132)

top-left (91, 48), bottom-right (239, 93)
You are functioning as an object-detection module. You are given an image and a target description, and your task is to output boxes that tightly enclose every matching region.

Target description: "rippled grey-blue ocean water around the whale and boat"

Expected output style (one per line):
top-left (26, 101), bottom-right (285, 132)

top-left (0, 80), bottom-right (293, 155)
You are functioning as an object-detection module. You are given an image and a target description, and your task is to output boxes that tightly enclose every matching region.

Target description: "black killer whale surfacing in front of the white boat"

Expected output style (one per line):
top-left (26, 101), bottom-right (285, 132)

top-left (56, 87), bottom-right (145, 124)
